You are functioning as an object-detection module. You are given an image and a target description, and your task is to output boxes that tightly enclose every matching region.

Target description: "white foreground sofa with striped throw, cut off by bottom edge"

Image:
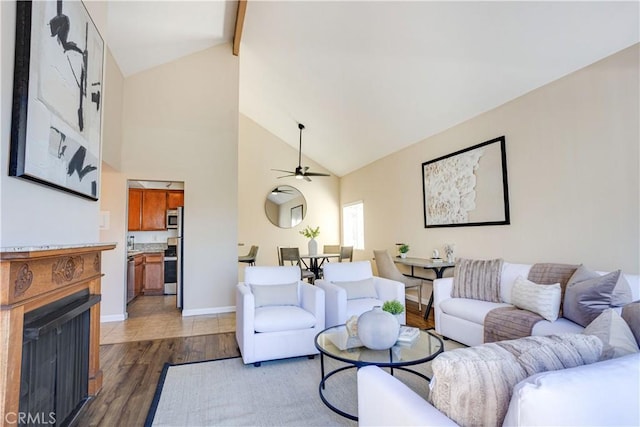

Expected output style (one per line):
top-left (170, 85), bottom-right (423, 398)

top-left (358, 353), bottom-right (640, 426)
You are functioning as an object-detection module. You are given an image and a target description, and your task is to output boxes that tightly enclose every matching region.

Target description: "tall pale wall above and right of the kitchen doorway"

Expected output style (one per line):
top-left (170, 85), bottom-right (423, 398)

top-left (114, 44), bottom-right (238, 315)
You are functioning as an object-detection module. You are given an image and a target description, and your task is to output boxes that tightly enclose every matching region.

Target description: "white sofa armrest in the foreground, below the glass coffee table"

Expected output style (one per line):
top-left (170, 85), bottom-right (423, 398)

top-left (358, 366), bottom-right (457, 426)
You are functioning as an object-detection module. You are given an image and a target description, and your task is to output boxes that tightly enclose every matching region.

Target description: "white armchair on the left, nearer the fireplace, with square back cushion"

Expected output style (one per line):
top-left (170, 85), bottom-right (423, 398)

top-left (236, 266), bottom-right (325, 366)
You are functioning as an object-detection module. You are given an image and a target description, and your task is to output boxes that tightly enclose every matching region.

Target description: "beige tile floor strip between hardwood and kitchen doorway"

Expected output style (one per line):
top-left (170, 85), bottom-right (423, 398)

top-left (100, 295), bottom-right (236, 344)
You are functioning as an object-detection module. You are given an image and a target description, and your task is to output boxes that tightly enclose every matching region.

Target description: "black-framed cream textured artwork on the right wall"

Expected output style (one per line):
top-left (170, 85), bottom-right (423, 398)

top-left (422, 136), bottom-right (510, 228)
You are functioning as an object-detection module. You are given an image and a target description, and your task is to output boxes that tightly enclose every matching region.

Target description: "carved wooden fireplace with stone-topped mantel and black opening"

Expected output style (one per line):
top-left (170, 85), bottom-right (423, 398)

top-left (0, 244), bottom-right (115, 426)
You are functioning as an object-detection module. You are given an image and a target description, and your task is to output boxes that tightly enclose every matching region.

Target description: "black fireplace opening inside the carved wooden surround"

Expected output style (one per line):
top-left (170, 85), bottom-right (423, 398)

top-left (18, 290), bottom-right (100, 426)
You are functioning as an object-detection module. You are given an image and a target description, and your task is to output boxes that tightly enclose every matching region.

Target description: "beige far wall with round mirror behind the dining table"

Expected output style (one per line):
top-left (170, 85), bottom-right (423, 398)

top-left (238, 114), bottom-right (340, 278)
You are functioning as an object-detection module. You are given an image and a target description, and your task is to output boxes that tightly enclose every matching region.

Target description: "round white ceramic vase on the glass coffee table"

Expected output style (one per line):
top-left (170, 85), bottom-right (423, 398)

top-left (358, 306), bottom-right (400, 350)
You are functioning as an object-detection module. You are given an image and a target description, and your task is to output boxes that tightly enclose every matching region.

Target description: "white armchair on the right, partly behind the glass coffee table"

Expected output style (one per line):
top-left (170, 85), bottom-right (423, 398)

top-left (315, 261), bottom-right (406, 327)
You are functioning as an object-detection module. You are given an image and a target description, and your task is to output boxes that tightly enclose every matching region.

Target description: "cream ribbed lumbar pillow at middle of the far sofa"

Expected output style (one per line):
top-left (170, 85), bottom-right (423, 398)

top-left (511, 276), bottom-right (561, 322)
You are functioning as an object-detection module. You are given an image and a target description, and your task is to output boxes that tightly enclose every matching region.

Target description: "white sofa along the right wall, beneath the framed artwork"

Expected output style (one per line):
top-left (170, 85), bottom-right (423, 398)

top-left (433, 262), bottom-right (640, 346)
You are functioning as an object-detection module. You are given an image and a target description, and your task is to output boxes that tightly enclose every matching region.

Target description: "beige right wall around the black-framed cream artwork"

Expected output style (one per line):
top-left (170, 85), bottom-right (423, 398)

top-left (341, 45), bottom-right (640, 274)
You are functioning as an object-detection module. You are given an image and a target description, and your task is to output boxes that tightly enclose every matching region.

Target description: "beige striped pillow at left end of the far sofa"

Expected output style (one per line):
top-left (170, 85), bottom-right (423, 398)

top-left (451, 258), bottom-right (503, 302)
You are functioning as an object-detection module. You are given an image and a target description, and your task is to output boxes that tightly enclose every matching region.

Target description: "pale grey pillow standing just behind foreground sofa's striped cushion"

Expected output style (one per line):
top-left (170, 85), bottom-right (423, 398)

top-left (582, 308), bottom-right (640, 360)
